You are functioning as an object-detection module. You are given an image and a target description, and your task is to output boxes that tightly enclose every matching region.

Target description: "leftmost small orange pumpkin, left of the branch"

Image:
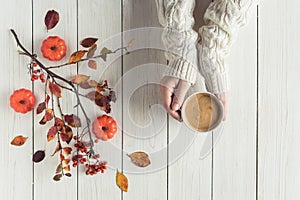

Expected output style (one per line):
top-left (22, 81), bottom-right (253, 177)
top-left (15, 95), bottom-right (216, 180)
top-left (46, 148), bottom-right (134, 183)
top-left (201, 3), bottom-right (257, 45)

top-left (9, 88), bottom-right (35, 114)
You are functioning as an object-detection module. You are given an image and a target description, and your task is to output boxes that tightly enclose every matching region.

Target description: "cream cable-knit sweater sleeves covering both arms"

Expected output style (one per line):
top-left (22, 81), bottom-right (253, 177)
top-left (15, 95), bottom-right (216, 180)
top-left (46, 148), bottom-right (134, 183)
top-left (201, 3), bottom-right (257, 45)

top-left (156, 0), bottom-right (257, 94)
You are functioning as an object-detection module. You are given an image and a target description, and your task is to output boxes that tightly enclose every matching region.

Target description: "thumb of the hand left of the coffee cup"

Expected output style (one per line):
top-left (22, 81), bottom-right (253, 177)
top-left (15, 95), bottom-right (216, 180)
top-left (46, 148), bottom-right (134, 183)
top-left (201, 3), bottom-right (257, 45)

top-left (171, 80), bottom-right (191, 111)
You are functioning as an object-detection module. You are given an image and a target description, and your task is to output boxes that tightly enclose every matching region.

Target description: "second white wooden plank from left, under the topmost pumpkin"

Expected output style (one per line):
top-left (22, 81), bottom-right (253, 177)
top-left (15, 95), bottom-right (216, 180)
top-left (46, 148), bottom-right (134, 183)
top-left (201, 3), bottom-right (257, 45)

top-left (33, 0), bottom-right (77, 199)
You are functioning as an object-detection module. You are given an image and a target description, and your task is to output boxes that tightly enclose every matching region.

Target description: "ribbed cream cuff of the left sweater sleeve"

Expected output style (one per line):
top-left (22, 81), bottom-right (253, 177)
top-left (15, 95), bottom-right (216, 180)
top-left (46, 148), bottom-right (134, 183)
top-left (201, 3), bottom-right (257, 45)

top-left (163, 58), bottom-right (197, 85)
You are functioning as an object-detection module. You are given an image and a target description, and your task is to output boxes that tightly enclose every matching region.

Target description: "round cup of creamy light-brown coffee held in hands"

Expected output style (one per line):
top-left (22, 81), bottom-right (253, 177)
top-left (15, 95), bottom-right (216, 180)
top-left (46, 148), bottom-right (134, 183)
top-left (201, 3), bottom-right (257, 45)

top-left (181, 92), bottom-right (224, 133)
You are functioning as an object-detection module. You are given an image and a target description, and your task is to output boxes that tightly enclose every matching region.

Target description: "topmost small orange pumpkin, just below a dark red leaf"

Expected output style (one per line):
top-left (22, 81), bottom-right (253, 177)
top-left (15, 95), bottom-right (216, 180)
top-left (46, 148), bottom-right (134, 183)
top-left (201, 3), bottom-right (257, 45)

top-left (41, 36), bottom-right (67, 61)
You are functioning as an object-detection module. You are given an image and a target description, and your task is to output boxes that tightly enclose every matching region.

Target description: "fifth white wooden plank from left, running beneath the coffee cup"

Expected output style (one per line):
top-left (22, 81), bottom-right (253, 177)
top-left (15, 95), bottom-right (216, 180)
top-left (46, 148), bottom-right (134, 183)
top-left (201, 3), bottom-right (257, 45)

top-left (168, 0), bottom-right (212, 200)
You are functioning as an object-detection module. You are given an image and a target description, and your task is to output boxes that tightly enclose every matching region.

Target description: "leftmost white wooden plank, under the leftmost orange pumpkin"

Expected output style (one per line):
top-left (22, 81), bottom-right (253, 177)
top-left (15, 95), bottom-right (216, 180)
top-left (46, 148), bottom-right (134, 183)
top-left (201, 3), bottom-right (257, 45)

top-left (0, 0), bottom-right (33, 200)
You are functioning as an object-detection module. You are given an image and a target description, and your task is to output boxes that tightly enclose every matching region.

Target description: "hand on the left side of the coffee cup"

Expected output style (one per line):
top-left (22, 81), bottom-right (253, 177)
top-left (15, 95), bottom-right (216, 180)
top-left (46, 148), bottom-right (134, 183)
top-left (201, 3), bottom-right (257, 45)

top-left (160, 76), bottom-right (191, 122)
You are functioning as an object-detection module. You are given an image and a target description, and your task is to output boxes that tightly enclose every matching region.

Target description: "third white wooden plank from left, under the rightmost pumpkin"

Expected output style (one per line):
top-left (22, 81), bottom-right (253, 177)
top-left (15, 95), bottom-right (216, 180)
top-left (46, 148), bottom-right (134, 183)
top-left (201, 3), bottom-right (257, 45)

top-left (78, 0), bottom-right (122, 200)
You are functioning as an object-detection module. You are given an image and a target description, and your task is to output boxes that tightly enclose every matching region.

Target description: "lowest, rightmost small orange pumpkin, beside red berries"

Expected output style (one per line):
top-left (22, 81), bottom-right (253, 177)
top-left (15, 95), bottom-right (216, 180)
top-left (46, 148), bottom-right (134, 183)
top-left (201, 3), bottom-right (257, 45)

top-left (92, 115), bottom-right (117, 141)
